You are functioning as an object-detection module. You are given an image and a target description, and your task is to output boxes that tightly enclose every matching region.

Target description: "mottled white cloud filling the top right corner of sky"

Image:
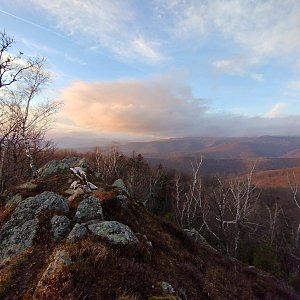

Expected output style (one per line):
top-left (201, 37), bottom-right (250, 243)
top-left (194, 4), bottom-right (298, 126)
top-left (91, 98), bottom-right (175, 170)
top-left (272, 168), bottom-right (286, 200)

top-left (156, 0), bottom-right (300, 72)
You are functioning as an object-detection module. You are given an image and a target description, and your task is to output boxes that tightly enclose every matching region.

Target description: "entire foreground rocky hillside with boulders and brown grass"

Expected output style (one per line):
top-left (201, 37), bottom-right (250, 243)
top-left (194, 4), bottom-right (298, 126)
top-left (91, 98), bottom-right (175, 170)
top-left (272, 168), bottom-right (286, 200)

top-left (0, 158), bottom-right (299, 300)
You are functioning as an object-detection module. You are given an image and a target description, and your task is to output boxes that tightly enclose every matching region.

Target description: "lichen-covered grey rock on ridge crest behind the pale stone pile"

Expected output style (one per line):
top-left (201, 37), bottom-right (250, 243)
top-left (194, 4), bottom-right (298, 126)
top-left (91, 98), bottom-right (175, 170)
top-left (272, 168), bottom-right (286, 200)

top-left (38, 157), bottom-right (87, 177)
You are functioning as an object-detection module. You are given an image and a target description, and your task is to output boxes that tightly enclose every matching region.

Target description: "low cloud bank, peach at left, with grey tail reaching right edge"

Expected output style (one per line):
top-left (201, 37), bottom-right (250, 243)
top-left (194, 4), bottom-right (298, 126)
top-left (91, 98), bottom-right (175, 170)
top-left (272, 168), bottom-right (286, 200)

top-left (61, 74), bottom-right (300, 138)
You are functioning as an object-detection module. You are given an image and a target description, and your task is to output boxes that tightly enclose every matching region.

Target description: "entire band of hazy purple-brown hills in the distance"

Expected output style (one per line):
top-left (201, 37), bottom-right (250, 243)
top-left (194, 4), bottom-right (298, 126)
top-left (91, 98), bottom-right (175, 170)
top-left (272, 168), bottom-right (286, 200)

top-left (58, 136), bottom-right (300, 175)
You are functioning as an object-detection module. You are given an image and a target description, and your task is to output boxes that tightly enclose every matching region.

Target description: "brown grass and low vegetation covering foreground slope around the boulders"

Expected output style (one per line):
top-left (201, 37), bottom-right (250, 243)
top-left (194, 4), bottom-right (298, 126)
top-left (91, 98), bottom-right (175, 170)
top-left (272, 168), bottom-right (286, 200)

top-left (0, 169), bottom-right (296, 300)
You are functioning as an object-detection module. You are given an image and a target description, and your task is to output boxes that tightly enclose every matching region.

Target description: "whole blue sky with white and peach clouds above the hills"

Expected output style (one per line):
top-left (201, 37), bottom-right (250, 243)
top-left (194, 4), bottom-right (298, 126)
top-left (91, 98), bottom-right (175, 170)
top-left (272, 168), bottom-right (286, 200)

top-left (0, 0), bottom-right (300, 145)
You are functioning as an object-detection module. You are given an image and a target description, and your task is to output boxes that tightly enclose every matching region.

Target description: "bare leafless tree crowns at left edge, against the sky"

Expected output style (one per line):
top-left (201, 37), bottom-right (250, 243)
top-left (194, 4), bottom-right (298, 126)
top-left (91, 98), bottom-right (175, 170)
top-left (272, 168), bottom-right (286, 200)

top-left (0, 32), bottom-right (60, 186)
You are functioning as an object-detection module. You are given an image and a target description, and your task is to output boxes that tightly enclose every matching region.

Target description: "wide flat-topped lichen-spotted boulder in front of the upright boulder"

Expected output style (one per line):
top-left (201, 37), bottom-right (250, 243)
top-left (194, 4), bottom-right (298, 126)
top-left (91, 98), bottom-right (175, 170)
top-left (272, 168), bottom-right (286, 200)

top-left (88, 221), bottom-right (138, 245)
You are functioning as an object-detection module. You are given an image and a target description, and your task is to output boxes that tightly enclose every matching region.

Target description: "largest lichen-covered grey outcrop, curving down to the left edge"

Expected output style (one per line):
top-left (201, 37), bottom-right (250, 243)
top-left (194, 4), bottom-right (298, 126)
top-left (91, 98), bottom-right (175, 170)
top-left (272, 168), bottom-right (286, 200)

top-left (0, 192), bottom-right (69, 261)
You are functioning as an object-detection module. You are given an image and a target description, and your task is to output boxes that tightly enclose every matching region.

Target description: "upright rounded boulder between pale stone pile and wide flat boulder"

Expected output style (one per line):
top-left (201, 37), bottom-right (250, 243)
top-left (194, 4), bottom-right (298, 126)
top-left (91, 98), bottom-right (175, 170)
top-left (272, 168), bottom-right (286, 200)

top-left (74, 196), bottom-right (103, 222)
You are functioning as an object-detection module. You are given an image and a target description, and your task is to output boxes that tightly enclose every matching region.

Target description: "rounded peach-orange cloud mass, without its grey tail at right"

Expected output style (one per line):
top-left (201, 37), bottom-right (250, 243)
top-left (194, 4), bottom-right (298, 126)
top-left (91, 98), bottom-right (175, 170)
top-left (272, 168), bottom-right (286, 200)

top-left (62, 78), bottom-right (205, 136)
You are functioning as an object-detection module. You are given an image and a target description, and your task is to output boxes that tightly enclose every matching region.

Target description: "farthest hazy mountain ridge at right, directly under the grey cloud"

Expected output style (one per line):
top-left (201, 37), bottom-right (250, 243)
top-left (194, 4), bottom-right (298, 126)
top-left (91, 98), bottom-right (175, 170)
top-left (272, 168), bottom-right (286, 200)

top-left (120, 136), bottom-right (300, 159)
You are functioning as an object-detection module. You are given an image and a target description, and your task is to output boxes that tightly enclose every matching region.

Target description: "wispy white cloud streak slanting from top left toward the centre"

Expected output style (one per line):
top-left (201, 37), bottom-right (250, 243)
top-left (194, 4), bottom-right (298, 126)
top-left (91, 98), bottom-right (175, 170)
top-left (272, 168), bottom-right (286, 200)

top-left (31, 0), bottom-right (163, 63)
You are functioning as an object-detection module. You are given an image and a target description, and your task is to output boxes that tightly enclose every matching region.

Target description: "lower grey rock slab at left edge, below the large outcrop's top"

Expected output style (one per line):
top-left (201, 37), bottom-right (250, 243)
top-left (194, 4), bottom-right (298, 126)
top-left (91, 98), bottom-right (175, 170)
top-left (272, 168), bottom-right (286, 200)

top-left (0, 219), bottom-right (39, 261)
